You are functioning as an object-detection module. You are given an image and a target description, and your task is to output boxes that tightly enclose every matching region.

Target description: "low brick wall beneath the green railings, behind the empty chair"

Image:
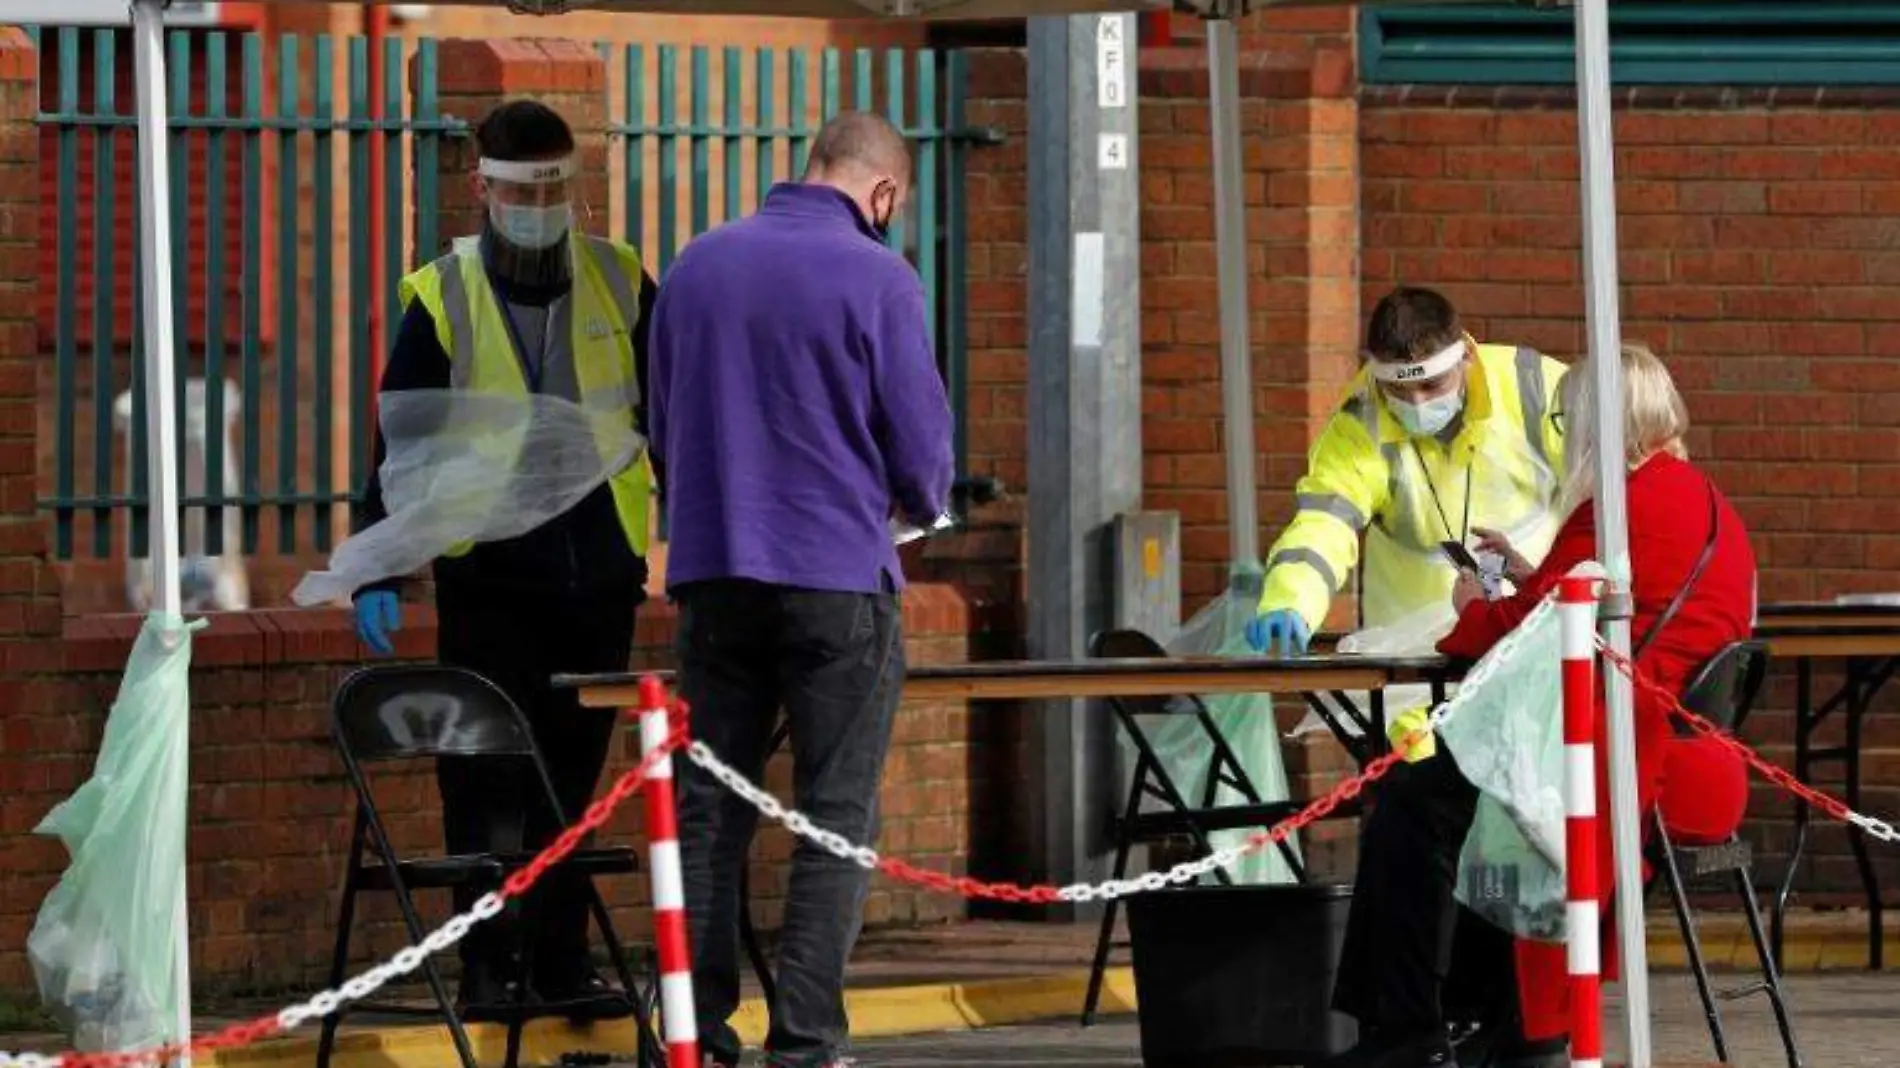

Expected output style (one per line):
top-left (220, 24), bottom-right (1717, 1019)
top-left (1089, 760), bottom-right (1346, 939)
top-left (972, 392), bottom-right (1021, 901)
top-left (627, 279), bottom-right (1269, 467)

top-left (0, 600), bottom-right (971, 996)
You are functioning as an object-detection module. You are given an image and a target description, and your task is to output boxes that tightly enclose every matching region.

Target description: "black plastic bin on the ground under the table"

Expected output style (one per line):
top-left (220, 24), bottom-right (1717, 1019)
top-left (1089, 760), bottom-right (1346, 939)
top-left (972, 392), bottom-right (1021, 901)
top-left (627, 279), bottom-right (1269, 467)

top-left (1127, 886), bottom-right (1359, 1068)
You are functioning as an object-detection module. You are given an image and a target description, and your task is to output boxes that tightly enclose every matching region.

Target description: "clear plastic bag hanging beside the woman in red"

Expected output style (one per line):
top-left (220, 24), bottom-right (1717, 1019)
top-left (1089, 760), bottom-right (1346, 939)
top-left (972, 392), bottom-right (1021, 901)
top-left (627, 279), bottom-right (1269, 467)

top-left (1438, 592), bottom-right (1566, 943)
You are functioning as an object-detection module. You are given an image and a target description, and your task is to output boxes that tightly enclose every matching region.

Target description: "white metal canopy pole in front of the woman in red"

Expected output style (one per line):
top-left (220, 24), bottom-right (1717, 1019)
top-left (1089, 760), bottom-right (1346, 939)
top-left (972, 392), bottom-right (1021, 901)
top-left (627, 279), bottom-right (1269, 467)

top-left (1575, 0), bottom-right (1651, 1068)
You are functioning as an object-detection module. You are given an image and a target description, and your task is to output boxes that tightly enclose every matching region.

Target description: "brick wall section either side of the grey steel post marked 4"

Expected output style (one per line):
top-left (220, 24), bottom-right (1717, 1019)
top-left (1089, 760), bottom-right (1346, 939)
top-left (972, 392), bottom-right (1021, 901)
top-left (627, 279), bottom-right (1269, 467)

top-left (944, 48), bottom-right (1359, 604)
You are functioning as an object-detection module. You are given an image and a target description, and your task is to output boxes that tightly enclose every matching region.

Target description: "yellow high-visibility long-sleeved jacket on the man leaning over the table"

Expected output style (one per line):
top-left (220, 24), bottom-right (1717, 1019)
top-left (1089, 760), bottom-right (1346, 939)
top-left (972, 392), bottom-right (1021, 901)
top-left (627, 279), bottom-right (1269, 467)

top-left (1260, 344), bottom-right (1568, 631)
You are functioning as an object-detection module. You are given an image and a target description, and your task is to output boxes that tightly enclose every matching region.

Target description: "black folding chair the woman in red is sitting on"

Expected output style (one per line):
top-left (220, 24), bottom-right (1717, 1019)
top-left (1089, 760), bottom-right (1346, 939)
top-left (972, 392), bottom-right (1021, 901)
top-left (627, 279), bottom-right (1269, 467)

top-left (1649, 640), bottom-right (1803, 1068)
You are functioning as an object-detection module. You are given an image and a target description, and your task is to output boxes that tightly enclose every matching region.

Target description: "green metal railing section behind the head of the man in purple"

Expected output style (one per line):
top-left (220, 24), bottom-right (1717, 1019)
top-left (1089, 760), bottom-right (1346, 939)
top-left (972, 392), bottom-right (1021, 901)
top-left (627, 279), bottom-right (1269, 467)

top-left (599, 44), bottom-right (1001, 473)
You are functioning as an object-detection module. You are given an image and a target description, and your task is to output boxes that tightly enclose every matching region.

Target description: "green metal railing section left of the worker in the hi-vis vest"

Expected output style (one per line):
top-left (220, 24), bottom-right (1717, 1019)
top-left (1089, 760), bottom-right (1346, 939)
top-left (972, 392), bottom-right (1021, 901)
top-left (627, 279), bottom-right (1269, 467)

top-left (34, 27), bottom-right (466, 559)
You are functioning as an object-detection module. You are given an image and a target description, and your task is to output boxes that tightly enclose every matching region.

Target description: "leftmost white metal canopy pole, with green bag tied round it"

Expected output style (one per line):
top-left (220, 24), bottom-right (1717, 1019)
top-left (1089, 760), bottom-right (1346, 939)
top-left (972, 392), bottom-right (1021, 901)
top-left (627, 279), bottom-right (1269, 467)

top-left (131, 0), bottom-right (192, 1066)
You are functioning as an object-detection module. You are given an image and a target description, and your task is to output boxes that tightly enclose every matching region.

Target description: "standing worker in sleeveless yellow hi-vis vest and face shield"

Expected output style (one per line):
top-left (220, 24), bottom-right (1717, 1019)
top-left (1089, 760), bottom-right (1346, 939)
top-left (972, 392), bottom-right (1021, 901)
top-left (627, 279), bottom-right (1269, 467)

top-left (353, 101), bottom-right (656, 1019)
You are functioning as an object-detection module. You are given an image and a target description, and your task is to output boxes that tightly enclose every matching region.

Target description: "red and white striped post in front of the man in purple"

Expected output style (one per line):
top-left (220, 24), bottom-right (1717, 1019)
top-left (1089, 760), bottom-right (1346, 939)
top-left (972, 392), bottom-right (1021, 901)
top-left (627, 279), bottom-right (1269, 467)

top-left (640, 675), bottom-right (701, 1068)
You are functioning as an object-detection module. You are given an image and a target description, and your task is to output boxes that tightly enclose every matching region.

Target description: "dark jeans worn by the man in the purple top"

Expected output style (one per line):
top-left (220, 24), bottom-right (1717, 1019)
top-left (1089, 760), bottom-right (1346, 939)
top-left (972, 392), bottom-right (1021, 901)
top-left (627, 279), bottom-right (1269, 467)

top-left (675, 580), bottom-right (904, 1066)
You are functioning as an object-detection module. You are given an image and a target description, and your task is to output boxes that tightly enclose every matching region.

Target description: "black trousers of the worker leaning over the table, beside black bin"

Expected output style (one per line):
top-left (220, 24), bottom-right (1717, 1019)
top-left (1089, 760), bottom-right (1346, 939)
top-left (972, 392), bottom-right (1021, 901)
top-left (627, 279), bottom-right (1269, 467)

top-left (1334, 745), bottom-right (1522, 1036)
